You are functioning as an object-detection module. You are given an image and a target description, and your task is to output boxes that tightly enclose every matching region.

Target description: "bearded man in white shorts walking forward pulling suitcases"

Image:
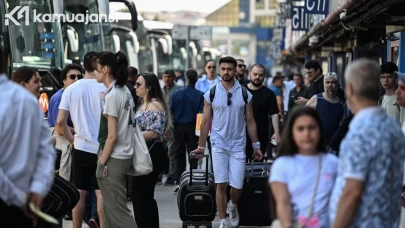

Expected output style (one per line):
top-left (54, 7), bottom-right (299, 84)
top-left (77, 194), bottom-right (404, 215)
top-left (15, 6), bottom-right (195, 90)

top-left (192, 57), bottom-right (263, 228)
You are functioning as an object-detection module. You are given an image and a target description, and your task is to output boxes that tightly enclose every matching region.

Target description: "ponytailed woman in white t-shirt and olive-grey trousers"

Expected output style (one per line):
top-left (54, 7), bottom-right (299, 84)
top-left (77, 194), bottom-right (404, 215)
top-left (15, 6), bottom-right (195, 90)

top-left (92, 51), bottom-right (136, 228)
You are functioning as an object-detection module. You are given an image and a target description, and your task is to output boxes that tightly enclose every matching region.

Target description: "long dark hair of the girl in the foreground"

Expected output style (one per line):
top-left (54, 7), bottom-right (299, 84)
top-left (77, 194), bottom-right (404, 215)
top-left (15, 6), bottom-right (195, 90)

top-left (277, 106), bottom-right (326, 157)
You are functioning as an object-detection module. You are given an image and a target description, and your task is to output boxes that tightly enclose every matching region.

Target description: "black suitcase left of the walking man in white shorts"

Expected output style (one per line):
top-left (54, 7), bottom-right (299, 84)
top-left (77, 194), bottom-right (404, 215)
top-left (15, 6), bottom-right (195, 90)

top-left (177, 155), bottom-right (216, 228)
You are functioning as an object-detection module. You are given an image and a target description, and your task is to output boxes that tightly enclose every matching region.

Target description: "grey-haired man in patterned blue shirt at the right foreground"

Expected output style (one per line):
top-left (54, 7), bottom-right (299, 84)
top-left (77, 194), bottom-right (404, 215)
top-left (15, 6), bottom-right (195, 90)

top-left (329, 59), bottom-right (405, 228)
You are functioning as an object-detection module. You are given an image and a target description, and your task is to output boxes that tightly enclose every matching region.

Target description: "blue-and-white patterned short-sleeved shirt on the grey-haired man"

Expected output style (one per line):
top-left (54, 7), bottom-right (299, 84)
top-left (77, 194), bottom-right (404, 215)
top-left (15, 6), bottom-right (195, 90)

top-left (329, 107), bottom-right (405, 228)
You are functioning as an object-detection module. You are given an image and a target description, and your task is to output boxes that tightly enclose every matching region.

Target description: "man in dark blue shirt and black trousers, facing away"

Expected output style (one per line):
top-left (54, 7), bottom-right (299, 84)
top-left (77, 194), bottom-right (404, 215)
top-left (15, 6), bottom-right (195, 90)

top-left (166, 69), bottom-right (204, 191)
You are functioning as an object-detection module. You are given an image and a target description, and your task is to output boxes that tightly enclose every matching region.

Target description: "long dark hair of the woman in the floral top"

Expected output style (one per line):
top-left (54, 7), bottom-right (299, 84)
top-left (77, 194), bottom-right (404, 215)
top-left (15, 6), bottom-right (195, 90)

top-left (139, 72), bottom-right (172, 129)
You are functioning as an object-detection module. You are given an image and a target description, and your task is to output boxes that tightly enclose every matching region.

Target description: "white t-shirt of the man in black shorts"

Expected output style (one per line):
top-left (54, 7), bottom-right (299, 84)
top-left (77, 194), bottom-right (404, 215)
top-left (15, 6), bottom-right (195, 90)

top-left (59, 79), bottom-right (106, 154)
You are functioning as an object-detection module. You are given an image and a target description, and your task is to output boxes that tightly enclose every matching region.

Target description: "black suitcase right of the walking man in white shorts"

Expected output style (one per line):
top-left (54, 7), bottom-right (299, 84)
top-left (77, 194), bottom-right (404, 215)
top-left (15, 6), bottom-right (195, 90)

top-left (238, 158), bottom-right (275, 226)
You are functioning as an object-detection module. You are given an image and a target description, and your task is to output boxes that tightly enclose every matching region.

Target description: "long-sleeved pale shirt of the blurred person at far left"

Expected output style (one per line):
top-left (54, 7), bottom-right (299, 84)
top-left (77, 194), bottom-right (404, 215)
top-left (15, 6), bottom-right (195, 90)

top-left (0, 74), bottom-right (56, 207)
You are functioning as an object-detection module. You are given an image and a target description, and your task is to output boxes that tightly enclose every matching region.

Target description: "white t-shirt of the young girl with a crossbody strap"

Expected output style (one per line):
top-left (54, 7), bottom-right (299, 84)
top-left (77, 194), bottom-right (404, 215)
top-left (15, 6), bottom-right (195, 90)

top-left (270, 154), bottom-right (338, 228)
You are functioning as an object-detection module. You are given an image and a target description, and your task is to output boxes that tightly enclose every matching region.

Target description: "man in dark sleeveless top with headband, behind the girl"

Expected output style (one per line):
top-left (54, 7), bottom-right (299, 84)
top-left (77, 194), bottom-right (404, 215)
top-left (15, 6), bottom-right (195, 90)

top-left (306, 72), bottom-right (345, 146)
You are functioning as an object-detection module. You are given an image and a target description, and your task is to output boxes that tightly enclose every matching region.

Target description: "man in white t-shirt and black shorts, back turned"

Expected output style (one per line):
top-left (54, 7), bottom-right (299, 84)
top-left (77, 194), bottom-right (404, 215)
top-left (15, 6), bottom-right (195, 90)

top-left (57, 52), bottom-right (106, 228)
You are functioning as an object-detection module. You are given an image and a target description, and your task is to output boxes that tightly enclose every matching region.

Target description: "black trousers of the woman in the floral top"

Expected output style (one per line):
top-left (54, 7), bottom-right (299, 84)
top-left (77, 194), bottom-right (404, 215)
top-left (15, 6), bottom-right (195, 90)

top-left (132, 142), bottom-right (169, 228)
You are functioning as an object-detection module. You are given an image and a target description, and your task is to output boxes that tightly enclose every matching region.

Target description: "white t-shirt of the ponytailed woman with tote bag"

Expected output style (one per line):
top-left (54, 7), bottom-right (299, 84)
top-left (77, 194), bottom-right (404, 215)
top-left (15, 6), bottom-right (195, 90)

top-left (103, 86), bottom-right (135, 159)
